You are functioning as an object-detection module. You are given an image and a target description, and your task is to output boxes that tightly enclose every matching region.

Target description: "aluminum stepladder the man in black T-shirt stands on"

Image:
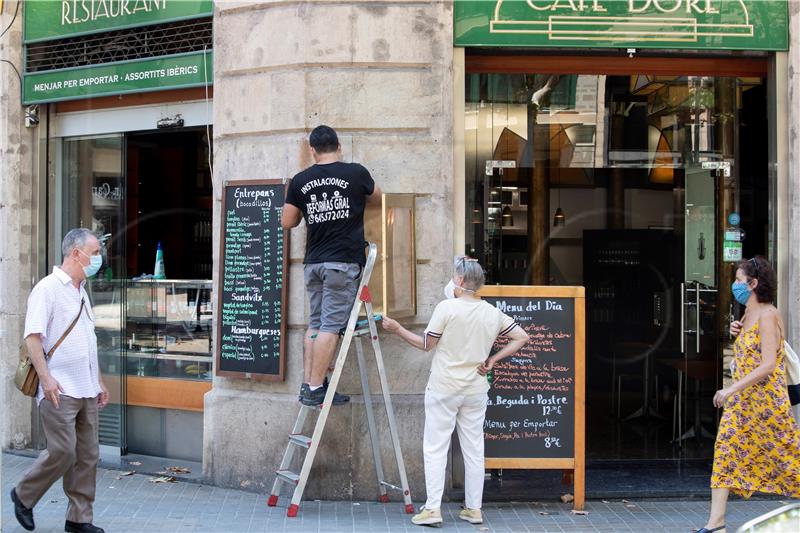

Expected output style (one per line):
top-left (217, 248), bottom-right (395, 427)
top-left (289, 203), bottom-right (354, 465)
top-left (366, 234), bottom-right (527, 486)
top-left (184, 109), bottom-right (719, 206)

top-left (267, 243), bottom-right (414, 517)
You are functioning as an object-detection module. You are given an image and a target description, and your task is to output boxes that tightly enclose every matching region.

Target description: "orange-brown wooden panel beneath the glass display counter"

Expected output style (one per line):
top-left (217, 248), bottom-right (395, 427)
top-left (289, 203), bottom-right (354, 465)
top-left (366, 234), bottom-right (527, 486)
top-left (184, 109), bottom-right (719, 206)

top-left (127, 376), bottom-right (211, 412)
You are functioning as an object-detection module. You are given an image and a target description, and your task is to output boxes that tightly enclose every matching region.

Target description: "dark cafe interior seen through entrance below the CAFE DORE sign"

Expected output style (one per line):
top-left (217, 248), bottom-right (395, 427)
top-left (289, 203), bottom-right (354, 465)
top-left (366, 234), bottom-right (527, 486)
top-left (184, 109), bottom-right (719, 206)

top-left (465, 68), bottom-right (770, 466)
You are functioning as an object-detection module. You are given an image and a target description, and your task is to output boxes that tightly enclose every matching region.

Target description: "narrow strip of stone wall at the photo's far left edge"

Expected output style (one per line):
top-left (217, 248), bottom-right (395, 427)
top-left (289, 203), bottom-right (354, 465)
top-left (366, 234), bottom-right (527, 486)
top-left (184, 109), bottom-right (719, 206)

top-left (0, 1), bottom-right (37, 447)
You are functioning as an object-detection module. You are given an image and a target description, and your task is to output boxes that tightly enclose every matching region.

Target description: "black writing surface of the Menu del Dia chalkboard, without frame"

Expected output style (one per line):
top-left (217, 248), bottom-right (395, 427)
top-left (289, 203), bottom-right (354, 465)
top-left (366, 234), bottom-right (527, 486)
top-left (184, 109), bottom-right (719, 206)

top-left (483, 297), bottom-right (575, 457)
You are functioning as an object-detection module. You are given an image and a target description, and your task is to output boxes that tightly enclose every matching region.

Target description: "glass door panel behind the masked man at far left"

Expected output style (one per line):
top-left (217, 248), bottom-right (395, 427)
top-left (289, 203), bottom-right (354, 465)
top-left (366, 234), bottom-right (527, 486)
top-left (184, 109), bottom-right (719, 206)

top-left (55, 135), bottom-right (126, 453)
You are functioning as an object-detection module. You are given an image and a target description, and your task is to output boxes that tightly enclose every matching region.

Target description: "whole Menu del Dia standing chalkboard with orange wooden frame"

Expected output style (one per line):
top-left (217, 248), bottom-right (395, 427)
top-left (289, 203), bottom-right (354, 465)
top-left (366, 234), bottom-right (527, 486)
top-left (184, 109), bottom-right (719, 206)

top-left (480, 286), bottom-right (585, 509)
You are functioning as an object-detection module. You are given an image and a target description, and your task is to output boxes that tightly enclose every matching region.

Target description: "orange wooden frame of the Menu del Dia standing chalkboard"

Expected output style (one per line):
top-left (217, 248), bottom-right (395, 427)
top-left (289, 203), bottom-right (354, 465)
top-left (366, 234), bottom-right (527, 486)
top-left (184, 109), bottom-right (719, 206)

top-left (478, 285), bottom-right (586, 509)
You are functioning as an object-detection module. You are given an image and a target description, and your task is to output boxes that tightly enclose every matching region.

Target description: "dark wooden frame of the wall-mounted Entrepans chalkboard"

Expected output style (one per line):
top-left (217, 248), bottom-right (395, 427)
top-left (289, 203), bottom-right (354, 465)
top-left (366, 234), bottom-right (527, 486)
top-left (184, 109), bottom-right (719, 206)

top-left (214, 179), bottom-right (291, 381)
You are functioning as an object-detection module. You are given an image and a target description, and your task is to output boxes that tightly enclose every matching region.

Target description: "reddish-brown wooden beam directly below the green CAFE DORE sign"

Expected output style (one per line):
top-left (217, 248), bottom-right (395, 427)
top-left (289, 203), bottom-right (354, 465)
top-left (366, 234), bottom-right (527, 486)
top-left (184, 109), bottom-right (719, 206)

top-left (466, 54), bottom-right (768, 78)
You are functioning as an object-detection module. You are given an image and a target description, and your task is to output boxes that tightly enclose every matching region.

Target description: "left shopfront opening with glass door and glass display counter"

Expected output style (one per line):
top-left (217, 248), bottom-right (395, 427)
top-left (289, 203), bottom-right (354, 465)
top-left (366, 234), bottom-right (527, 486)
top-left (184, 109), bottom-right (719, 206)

top-left (53, 128), bottom-right (213, 460)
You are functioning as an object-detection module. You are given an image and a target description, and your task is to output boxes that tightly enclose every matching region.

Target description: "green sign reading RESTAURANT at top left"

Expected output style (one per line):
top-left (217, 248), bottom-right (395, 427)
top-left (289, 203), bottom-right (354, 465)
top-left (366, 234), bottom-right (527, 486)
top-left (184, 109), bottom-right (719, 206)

top-left (24, 0), bottom-right (214, 43)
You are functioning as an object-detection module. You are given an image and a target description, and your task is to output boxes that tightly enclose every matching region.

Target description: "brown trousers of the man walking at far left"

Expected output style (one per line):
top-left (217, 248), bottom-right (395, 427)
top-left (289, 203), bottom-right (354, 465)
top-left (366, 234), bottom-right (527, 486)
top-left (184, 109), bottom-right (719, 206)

top-left (16, 395), bottom-right (100, 522)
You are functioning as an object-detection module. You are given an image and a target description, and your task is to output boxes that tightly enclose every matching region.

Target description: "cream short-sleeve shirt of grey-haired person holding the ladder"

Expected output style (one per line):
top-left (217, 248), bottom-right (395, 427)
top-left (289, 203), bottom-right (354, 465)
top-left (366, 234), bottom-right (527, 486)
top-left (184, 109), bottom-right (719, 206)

top-left (425, 298), bottom-right (518, 394)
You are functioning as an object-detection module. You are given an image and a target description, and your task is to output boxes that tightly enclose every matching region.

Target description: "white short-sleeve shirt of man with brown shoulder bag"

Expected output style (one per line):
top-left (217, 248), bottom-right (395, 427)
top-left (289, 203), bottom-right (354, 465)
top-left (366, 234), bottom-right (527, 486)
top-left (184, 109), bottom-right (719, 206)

top-left (24, 267), bottom-right (101, 402)
